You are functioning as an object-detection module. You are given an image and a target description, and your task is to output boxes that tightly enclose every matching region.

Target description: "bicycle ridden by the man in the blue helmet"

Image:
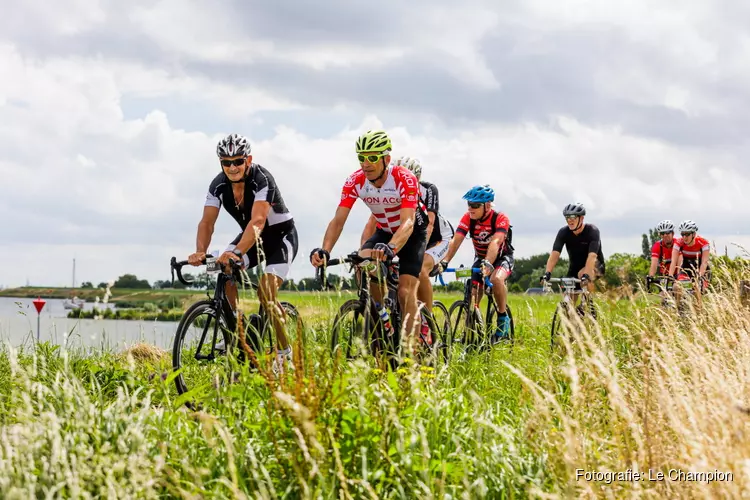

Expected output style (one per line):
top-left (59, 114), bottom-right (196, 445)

top-left (439, 265), bottom-right (516, 354)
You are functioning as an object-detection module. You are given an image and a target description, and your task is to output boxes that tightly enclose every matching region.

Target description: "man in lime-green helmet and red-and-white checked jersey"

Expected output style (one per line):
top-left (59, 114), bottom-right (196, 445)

top-left (310, 130), bottom-right (427, 341)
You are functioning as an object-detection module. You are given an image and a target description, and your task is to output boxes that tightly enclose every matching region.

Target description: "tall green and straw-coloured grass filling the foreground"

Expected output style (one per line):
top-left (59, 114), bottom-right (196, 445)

top-left (0, 270), bottom-right (750, 498)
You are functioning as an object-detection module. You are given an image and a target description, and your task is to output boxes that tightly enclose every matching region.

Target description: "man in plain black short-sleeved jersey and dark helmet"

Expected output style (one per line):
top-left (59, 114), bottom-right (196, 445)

top-left (541, 203), bottom-right (605, 294)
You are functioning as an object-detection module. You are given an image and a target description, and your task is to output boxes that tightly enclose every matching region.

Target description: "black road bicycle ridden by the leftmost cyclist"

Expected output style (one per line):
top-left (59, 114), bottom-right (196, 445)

top-left (170, 256), bottom-right (304, 402)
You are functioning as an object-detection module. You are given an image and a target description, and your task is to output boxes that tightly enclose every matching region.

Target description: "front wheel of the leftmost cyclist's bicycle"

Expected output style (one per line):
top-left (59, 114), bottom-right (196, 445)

top-left (172, 300), bottom-right (234, 402)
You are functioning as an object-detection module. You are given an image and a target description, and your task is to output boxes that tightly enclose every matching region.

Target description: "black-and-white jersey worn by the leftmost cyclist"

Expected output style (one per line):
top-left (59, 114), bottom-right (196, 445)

top-left (205, 163), bottom-right (294, 232)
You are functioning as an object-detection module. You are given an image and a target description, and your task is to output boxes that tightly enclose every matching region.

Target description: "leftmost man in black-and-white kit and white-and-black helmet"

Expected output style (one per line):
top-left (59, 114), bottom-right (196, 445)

top-left (188, 134), bottom-right (299, 369)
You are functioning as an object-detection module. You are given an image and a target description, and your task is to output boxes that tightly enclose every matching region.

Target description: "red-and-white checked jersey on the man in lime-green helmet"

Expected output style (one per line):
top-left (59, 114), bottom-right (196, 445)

top-left (339, 165), bottom-right (424, 234)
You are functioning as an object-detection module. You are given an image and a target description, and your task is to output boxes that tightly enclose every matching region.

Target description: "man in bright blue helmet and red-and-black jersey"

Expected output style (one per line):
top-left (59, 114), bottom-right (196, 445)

top-left (441, 185), bottom-right (514, 342)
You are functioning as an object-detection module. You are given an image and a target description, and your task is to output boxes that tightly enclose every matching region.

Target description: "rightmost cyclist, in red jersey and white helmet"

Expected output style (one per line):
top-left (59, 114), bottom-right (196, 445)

top-left (669, 220), bottom-right (711, 292)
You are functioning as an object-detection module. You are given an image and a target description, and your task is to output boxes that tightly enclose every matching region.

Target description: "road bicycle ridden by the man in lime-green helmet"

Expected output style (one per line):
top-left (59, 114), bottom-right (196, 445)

top-left (316, 252), bottom-right (445, 369)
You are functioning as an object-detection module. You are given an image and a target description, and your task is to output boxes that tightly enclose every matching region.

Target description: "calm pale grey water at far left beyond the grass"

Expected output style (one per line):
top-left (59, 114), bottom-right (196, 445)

top-left (0, 297), bottom-right (177, 351)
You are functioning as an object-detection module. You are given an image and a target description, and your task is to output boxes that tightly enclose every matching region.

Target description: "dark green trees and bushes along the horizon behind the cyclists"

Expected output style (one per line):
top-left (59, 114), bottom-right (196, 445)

top-left (76, 229), bottom-right (744, 292)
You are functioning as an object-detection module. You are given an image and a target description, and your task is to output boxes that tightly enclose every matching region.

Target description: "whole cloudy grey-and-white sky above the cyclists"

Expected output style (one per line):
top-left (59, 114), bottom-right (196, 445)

top-left (0, 0), bottom-right (750, 287)
